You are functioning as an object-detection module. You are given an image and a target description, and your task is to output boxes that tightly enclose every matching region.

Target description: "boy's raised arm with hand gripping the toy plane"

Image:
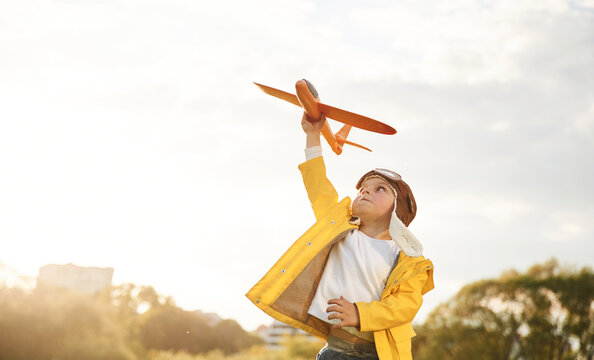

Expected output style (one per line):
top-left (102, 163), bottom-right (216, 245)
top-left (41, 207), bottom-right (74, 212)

top-left (299, 113), bottom-right (338, 219)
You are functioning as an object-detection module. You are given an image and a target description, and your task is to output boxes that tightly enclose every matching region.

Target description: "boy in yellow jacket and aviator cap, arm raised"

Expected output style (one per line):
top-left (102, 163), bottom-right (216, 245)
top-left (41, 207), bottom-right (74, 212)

top-left (247, 114), bottom-right (433, 360)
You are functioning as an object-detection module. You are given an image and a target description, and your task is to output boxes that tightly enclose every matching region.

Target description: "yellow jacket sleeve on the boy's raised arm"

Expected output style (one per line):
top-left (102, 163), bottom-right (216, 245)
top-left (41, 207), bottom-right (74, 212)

top-left (299, 156), bottom-right (338, 220)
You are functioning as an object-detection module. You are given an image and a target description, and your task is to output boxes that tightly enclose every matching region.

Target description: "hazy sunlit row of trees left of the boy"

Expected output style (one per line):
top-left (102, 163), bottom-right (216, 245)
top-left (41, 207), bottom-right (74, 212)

top-left (0, 284), bottom-right (263, 360)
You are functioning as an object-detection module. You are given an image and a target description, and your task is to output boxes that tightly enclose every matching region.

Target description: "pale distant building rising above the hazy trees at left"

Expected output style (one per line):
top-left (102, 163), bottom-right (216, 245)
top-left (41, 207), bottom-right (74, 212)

top-left (37, 264), bottom-right (113, 294)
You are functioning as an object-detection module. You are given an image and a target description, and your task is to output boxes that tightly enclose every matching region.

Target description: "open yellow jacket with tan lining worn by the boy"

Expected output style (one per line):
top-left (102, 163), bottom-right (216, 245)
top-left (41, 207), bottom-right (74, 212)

top-left (246, 157), bottom-right (433, 360)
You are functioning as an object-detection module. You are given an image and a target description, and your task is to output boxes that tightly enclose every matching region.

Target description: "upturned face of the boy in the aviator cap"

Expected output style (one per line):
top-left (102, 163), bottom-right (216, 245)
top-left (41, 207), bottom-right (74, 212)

top-left (353, 177), bottom-right (396, 222)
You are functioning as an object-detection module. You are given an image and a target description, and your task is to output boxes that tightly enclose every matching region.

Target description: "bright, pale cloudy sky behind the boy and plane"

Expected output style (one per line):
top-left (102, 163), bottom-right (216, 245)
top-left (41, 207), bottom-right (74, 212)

top-left (0, 0), bottom-right (594, 330)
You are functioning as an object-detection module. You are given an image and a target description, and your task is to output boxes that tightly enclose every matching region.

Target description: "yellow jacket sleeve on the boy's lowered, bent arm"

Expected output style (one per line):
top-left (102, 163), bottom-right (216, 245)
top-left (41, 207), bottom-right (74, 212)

top-left (356, 270), bottom-right (432, 332)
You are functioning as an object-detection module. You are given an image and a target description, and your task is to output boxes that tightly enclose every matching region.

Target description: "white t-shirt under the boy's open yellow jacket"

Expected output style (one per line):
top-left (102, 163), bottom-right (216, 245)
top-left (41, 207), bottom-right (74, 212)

top-left (308, 229), bottom-right (399, 324)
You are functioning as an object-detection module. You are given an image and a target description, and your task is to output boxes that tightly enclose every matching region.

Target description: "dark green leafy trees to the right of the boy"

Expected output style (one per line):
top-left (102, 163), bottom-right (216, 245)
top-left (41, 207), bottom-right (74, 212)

top-left (413, 259), bottom-right (594, 360)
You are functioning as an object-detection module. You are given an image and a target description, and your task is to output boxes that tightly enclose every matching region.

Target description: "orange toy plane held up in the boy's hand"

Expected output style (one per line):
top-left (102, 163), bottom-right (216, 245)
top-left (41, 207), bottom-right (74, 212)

top-left (254, 79), bottom-right (396, 155)
